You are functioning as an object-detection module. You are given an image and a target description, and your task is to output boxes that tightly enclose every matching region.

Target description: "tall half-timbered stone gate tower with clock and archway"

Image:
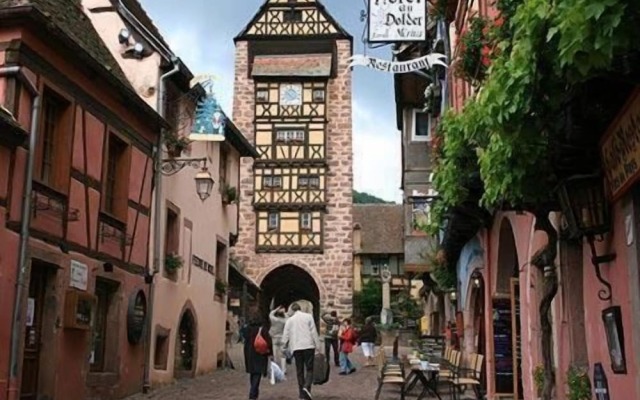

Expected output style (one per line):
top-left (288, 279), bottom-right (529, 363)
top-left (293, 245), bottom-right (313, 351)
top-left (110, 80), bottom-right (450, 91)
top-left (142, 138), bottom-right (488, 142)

top-left (233, 0), bottom-right (353, 316)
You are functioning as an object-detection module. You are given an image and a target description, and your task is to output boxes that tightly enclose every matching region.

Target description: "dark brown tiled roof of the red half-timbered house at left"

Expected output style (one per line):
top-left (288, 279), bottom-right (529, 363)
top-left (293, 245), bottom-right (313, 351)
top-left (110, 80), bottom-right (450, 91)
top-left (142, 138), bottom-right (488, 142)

top-left (0, 0), bottom-right (131, 88)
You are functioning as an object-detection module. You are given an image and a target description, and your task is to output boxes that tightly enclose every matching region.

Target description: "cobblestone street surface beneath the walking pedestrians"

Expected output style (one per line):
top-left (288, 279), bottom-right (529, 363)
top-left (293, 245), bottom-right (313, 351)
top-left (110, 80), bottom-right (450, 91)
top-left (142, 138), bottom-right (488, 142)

top-left (127, 348), bottom-right (424, 400)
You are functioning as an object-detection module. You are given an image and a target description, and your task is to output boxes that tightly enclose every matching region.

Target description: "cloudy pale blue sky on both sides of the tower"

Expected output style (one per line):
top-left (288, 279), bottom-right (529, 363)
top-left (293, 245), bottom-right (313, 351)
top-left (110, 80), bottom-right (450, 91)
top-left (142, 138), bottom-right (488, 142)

top-left (141, 0), bottom-right (402, 202)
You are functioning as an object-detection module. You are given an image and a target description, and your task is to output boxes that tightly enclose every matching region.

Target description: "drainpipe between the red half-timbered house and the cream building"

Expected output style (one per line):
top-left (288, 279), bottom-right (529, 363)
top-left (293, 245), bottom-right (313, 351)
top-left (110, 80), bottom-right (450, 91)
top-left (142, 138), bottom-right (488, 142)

top-left (142, 58), bottom-right (180, 393)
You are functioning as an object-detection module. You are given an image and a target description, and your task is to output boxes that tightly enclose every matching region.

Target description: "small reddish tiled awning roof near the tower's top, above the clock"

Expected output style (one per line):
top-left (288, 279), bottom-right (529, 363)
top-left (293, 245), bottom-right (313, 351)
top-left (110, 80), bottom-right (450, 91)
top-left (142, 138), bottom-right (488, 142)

top-left (252, 54), bottom-right (332, 76)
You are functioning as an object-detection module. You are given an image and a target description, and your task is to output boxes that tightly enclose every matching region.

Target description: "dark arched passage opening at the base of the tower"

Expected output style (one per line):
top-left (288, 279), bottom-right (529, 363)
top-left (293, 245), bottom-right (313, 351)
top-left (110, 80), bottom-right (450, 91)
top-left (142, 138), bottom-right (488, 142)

top-left (260, 264), bottom-right (320, 323)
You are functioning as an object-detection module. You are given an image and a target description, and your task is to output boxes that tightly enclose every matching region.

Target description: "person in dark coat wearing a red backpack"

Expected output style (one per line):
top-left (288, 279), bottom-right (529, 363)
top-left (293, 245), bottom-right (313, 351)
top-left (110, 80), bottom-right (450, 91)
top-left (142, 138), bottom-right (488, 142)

top-left (244, 315), bottom-right (273, 400)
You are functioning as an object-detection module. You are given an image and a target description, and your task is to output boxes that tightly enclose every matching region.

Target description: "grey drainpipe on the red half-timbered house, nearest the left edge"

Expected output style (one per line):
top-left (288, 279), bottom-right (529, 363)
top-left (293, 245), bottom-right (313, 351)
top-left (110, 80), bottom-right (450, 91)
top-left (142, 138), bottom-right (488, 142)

top-left (0, 66), bottom-right (41, 400)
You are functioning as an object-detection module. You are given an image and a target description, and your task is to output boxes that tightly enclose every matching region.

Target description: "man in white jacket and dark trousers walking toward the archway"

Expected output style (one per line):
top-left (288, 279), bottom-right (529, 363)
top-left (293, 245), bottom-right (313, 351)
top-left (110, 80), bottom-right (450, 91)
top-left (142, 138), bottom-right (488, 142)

top-left (282, 303), bottom-right (320, 400)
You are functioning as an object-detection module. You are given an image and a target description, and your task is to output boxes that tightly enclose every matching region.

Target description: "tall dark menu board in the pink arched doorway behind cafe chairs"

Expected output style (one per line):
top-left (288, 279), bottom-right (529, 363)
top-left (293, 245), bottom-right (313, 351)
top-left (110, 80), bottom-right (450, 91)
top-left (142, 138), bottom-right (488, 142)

top-left (493, 299), bottom-right (514, 393)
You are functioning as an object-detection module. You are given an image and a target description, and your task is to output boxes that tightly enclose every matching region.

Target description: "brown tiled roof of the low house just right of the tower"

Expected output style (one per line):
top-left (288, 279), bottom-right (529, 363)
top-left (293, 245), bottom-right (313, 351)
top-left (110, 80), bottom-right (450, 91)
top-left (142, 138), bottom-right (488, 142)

top-left (353, 204), bottom-right (404, 254)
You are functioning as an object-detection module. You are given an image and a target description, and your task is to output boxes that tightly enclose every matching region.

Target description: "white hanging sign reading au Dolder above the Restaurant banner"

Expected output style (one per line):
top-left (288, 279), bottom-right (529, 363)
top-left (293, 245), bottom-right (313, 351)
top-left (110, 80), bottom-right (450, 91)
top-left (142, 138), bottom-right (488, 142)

top-left (368, 0), bottom-right (427, 42)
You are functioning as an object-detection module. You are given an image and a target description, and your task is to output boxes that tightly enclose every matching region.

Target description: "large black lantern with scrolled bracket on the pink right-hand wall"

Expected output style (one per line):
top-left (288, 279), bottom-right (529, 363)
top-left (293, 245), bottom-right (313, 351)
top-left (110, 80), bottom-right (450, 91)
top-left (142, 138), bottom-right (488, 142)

top-left (557, 175), bottom-right (616, 301)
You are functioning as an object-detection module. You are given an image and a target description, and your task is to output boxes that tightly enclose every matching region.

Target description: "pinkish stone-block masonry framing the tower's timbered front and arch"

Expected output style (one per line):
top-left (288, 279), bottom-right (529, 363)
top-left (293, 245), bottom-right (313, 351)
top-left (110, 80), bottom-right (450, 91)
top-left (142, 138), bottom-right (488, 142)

top-left (233, 40), bottom-right (353, 316)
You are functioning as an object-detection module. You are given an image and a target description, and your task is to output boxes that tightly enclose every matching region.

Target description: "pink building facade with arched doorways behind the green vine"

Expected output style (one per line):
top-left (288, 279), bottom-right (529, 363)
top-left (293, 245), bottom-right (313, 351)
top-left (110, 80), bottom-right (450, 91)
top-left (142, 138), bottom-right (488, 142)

top-left (445, 1), bottom-right (640, 400)
